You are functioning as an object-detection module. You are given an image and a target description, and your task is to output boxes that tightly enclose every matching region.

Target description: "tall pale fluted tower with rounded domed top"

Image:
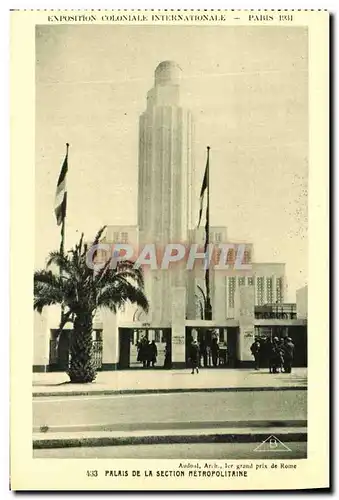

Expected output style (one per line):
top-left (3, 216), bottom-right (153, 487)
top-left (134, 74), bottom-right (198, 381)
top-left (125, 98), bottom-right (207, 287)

top-left (138, 61), bottom-right (194, 324)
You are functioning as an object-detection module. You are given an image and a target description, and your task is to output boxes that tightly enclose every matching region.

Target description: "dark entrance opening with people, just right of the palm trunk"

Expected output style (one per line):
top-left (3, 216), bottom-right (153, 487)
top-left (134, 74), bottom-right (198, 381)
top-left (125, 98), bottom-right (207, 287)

top-left (118, 328), bottom-right (172, 370)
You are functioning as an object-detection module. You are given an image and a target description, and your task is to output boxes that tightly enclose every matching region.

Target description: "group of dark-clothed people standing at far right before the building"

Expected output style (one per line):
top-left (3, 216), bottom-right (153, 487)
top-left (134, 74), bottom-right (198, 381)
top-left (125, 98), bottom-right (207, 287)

top-left (251, 337), bottom-right (294, 373)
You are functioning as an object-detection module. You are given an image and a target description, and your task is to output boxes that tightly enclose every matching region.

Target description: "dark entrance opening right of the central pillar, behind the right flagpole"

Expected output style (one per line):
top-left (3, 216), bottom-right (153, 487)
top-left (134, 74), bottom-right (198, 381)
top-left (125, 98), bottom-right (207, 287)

top-left (186, 327), bottom-right (238, 368)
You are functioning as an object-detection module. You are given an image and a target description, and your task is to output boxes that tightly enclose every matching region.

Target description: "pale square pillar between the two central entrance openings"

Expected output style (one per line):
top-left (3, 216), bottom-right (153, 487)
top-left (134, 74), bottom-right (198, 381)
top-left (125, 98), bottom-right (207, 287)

top-left (172, 287), bottom-right (186, 368)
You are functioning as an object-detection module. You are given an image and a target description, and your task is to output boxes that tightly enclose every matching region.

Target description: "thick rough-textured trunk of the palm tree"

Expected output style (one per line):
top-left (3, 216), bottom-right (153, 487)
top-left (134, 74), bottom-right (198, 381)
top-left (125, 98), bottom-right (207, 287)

top-left (68, 313), bottom-right (96, 384)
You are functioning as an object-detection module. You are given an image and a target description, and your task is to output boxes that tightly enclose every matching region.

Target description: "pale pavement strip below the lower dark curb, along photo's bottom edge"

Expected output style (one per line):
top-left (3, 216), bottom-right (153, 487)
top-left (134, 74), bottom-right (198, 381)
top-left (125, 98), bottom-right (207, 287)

top-left (33, 441), bottom-right (307, 460)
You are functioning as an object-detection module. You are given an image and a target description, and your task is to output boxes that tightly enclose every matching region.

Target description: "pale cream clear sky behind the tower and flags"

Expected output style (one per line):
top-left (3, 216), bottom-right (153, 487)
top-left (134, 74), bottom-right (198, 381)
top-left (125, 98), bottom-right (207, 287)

top-left (35, 25), bottom-right (308, 301)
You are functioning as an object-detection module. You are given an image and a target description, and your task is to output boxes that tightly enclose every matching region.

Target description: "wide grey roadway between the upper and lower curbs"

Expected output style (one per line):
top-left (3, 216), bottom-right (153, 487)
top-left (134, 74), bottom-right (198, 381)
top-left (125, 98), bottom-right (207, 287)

top-left (33, 390), bottom-right (307, 432)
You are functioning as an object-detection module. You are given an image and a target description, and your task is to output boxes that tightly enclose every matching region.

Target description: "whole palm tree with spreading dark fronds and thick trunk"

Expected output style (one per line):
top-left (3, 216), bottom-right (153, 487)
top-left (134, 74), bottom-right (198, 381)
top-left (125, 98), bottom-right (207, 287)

top-left (34, 227), bottom-right (148, 383)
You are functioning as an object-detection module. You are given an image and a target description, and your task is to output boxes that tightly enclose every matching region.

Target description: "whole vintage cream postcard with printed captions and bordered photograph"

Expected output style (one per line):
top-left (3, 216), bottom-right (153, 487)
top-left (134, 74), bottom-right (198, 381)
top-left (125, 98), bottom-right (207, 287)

top-left (11, 10), bottom-right (330, 491)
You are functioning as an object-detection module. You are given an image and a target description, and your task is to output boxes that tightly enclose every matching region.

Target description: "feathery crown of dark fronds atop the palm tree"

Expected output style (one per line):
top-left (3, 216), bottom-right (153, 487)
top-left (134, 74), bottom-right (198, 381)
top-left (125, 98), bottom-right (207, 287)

top-left (34, 226), bottom-right (148, 317)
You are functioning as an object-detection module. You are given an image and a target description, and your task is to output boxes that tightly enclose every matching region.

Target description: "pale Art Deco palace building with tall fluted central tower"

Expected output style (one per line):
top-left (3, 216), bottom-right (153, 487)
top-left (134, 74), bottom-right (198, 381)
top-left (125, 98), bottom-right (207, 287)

top-left (33, 61), bottom-right (307, 371)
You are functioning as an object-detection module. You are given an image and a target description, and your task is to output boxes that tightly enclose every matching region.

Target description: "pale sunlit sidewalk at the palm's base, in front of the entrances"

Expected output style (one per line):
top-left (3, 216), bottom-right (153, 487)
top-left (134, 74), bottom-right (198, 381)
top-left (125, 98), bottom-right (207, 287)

top-left (33, 368), bottom-right (307, 397)
